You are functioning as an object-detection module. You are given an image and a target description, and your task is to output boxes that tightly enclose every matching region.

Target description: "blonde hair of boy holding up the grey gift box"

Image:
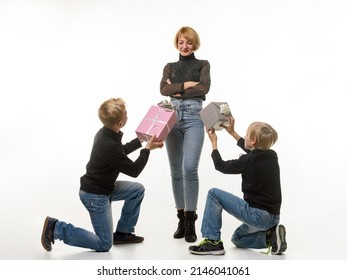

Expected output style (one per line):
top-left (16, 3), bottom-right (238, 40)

top-left (248, 122), bottom-right (278, 150)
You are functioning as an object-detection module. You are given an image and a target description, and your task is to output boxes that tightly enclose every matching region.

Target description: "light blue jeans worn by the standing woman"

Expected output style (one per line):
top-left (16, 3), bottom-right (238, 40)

top-left (165, 99), bottom-right (205, 211)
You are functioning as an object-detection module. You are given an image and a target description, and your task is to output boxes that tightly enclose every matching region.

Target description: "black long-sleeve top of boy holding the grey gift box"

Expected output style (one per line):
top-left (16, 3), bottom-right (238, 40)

top-left (211, 138), bottom-right (282, 215)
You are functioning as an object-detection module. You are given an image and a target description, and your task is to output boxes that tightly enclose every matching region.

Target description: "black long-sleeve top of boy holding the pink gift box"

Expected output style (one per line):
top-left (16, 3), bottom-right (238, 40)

top-left (80, 127), bottom-right (150, 195)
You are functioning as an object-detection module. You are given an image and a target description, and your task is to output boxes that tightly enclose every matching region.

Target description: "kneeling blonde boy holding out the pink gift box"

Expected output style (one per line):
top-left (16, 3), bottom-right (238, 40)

top-left (41, 98), bottom-right (163, 252)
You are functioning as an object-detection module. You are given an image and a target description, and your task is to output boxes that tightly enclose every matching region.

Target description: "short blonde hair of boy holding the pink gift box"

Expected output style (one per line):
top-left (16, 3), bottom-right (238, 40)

top-left (98, 98), bottom-right (126, 128)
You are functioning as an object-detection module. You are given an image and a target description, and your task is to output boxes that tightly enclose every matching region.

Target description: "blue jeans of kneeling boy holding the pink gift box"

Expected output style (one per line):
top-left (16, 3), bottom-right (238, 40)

top-left (54, 181), bottom-right (145, 252)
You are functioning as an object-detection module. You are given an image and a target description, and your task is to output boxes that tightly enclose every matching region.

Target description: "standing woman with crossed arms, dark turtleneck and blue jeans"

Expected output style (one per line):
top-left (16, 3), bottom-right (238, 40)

top-left (160, 26), bottom-right (211, 242)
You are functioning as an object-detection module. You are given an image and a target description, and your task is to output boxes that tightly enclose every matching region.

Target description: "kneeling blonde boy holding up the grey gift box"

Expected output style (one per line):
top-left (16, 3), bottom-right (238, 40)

top-left (189, 116), bottom-right (287, 255)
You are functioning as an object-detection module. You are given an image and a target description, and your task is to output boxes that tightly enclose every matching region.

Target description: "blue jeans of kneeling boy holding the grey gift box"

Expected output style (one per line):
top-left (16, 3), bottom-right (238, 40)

top-left (201, 188), bottom-right (280, 249)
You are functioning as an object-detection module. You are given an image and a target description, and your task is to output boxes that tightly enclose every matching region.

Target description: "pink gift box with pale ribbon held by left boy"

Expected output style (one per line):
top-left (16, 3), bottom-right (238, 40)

top-left (135, 105), bottom-right (176, 141)
